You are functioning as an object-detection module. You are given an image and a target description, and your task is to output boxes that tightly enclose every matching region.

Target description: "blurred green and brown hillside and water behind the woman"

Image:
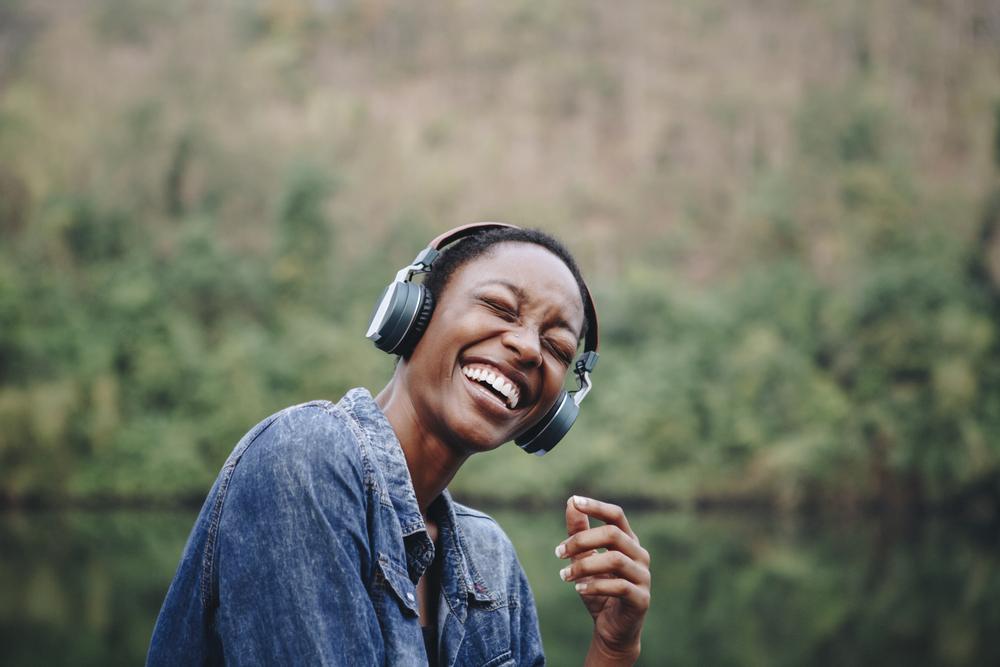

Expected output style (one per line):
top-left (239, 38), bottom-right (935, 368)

top-left (0, 0), bottom-right (1000, 665)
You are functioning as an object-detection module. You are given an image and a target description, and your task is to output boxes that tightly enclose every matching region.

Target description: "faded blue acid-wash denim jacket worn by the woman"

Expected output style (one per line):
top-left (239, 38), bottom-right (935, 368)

top-left (146, 389), bottom-right (545, 667)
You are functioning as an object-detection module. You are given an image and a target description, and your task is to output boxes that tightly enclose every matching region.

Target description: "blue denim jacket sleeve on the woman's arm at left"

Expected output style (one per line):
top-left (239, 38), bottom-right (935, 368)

top-left (213, 406), bottom-right (384, 665)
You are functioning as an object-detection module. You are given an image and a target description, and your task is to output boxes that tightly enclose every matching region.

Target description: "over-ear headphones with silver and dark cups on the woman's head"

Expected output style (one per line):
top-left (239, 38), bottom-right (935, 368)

top-left (365, 222), bottom-right (598, 456)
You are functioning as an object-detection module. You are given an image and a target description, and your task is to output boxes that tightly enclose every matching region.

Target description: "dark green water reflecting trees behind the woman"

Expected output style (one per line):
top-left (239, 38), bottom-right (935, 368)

top-left (0, 511), bottom-right (1000, 665)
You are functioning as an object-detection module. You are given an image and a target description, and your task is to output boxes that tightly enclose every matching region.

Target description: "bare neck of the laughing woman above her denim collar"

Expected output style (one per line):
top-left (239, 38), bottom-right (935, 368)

top-left (375, 373), bottom-right (469, 520)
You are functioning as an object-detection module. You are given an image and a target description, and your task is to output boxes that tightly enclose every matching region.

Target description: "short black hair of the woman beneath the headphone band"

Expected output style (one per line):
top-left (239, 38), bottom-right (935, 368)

top-left (424, 227), bottom-right (591, 340)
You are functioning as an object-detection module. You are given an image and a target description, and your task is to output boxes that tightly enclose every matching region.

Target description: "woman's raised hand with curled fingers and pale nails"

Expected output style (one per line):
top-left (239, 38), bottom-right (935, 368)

top-left (556, 496), bottom-right (650, 665)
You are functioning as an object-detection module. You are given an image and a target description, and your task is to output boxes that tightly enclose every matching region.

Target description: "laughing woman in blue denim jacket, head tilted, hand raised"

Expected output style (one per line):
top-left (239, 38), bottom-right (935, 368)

top-left (147, 223), bottom-right (650, 666)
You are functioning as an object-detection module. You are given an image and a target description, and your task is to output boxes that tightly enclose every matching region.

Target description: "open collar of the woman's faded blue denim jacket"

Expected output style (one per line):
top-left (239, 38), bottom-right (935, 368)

top-left (341, 387), bottom-right (501, 609)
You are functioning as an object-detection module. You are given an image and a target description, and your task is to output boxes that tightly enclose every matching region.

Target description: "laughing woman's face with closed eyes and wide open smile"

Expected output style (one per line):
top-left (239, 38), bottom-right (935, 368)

top-left (405, 242), bottom-right (584, 453)
